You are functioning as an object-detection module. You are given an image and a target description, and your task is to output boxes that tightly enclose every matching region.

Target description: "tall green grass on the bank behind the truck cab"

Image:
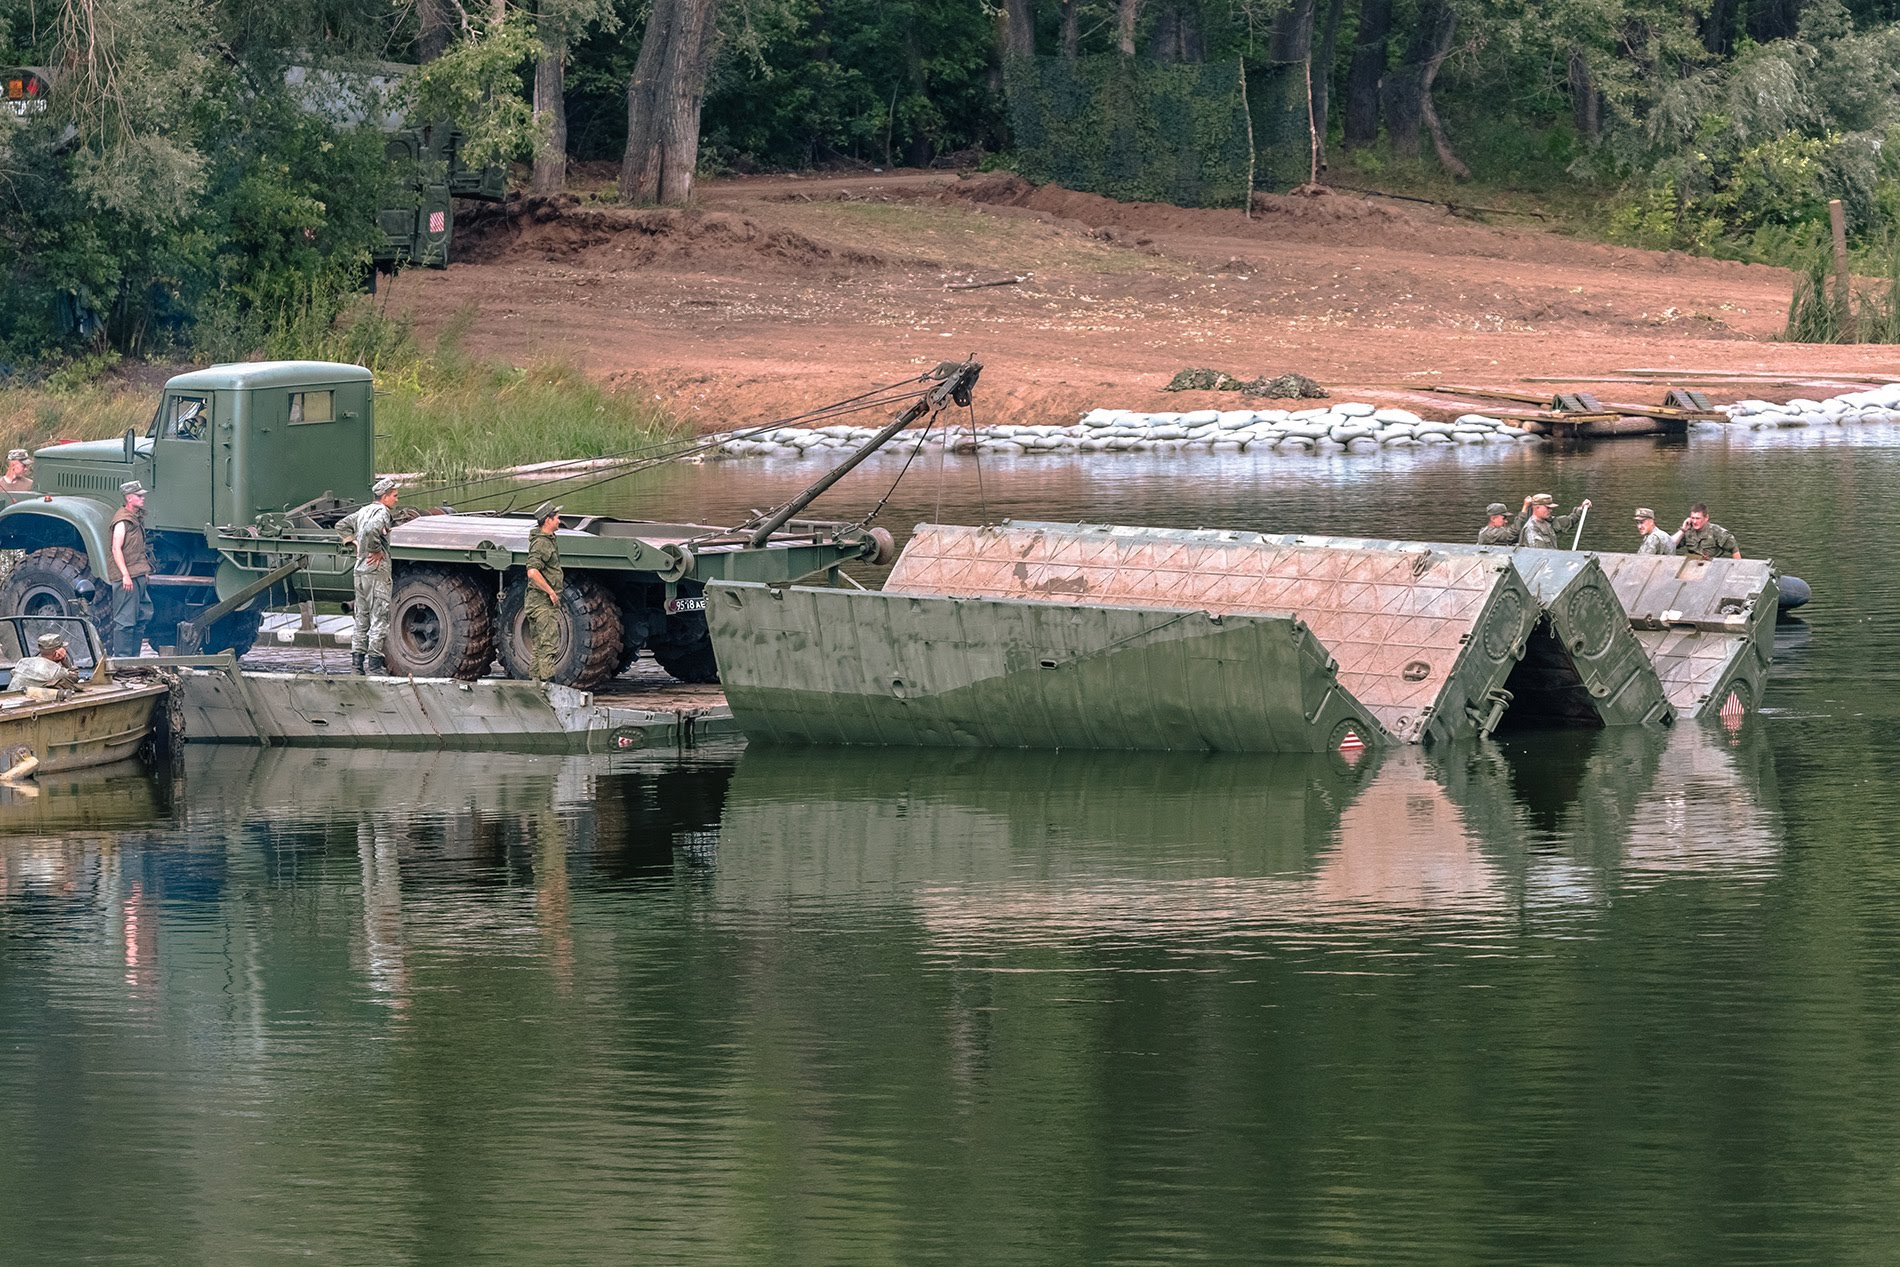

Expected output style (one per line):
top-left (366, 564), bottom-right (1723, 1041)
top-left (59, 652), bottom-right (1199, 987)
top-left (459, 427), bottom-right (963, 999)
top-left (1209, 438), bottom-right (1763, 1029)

top-left (0, 300), bottom-right (688, 481)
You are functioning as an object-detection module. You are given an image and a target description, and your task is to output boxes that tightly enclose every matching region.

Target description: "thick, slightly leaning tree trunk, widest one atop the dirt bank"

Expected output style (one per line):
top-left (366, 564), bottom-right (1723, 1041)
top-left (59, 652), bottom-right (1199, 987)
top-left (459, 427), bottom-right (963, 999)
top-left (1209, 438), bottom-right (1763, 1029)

top-left (619, 0), bottom-right (718, 205)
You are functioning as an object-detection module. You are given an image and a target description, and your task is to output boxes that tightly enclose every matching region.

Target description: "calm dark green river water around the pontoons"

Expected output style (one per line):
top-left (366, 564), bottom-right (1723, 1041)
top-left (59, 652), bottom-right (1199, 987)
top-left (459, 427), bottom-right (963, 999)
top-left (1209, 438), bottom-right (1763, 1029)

top-left (0, 429), bottom-right (1900, 1265)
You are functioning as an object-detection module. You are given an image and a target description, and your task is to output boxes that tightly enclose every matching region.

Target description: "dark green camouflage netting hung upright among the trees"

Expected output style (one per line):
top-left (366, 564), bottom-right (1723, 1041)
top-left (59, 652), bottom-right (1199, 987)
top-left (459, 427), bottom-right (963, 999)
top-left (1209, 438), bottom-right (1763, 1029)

top-left (1003, 57), bottom-right (1311, 207)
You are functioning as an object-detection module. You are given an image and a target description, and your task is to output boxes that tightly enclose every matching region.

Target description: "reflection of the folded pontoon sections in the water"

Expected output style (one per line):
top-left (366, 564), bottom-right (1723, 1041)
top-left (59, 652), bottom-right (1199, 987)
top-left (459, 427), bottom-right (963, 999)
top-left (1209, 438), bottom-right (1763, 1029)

top-left (718, 726), bottom-right (1778, 946)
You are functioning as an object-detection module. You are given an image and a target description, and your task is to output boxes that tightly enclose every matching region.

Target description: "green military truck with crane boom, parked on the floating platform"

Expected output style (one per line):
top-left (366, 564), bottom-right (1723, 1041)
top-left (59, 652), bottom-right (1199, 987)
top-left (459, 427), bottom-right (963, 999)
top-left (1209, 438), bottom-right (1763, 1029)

top-left (0, 361), bottom-right (965, 690)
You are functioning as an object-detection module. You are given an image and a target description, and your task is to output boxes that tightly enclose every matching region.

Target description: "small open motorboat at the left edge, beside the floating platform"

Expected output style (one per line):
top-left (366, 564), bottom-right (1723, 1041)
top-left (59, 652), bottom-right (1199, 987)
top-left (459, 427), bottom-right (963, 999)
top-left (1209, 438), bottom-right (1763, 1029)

top-left (0, 615), bottom-right (171, 777)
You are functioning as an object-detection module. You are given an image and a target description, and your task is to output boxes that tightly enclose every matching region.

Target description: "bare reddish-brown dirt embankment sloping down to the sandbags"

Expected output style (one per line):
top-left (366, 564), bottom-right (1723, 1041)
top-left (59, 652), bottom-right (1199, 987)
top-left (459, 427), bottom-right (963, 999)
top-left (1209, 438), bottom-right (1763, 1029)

top-left (393, 173), bottom-right (1891, 429)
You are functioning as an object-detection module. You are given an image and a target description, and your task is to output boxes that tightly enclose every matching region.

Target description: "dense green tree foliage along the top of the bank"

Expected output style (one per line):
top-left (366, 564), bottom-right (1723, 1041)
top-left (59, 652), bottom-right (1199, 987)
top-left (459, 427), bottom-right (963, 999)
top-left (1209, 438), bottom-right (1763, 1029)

top-left (11, 0), bottom-right (1900, 367)
